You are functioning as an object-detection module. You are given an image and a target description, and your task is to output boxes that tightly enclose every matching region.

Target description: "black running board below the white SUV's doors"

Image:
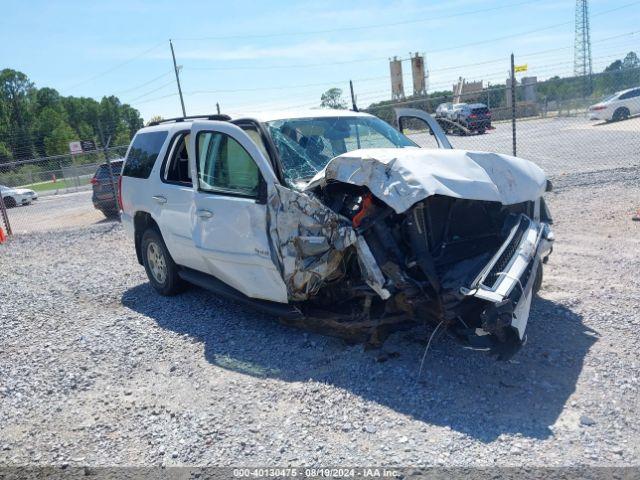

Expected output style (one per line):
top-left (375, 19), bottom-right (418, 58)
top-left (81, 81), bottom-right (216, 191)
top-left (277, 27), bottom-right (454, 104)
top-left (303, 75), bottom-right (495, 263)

top-left (178, 267), bottom-right (303, 320)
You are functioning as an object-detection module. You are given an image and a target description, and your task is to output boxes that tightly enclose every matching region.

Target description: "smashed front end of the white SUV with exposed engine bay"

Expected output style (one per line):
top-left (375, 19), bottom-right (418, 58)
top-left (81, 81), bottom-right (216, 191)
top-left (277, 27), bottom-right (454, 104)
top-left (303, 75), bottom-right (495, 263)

top-left (268, 151), bottom-right (553, 359)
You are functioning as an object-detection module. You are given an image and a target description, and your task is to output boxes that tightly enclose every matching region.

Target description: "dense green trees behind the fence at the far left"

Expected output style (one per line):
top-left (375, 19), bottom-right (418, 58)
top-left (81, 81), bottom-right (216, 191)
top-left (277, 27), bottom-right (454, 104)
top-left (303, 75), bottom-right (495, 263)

top-left (0, 68), bottom-right (143, 163)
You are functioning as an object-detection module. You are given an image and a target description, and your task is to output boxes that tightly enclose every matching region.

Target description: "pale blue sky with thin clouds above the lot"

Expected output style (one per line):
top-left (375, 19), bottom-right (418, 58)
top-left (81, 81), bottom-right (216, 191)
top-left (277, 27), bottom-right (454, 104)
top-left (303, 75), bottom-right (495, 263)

top-left (0, 0), bottom-right (640, 118)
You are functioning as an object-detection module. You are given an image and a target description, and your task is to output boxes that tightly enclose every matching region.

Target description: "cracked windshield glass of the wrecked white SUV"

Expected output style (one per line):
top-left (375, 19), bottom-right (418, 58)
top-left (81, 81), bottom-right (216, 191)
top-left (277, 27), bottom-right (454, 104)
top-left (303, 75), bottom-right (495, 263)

top-left (267, 116), bottom-right (417, 182)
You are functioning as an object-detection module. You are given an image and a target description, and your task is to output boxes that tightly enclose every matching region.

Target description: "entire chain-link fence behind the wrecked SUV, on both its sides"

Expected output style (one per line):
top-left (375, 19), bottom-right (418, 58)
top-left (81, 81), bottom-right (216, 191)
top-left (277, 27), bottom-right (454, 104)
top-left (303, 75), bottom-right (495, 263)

top-left (0, 59), bottom-right (640, 234)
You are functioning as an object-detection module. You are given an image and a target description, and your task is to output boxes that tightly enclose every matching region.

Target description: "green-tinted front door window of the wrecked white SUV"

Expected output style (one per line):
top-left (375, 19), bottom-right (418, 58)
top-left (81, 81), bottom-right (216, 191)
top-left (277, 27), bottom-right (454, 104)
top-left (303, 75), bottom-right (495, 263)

top-left (197, 132), bottom-right (261, 197)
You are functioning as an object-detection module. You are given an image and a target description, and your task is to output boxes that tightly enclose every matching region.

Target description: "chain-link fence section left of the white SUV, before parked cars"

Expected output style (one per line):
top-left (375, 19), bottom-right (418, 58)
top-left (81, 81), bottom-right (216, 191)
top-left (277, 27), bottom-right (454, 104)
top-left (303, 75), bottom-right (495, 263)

top-left (0, 146), bottom-right (127, 235)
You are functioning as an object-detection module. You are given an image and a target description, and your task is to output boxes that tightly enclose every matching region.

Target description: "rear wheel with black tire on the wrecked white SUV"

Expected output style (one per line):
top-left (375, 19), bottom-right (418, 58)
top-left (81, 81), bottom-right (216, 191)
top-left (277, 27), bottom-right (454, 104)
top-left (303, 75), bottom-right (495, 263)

top-left (141, 228), bottom-right (184, 296)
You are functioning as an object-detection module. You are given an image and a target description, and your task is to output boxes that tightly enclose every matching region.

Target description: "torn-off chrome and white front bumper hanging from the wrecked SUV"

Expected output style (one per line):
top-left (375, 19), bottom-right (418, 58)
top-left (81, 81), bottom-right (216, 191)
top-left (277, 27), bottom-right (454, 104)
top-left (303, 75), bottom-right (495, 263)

top-left (460, 215), bottom-right (554, 359)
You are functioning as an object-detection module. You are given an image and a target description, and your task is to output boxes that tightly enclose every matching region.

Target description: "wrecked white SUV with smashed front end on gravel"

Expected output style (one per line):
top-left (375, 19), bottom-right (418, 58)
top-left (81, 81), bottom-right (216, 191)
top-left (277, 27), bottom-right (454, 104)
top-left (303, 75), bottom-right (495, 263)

top-left (120, 109), bottom-right (553, 358)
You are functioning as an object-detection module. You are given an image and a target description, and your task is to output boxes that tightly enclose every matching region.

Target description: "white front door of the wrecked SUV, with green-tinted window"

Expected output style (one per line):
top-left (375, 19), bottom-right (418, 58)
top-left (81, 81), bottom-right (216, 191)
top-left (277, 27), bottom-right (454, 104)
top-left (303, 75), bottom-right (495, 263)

top-left (189, 121), bottom-right (287, 303)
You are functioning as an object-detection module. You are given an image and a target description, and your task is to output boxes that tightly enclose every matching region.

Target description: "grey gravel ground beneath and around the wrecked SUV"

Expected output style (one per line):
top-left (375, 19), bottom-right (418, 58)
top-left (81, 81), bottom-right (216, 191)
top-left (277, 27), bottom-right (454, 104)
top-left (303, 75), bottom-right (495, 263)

top-left (0, 181), bottom-right (640, 466)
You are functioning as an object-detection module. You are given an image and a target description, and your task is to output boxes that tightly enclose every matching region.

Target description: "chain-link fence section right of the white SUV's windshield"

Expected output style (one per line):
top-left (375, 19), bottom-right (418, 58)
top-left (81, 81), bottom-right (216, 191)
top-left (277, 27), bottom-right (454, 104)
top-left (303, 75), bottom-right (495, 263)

top-left (367, 62), bottom-right (640, 188)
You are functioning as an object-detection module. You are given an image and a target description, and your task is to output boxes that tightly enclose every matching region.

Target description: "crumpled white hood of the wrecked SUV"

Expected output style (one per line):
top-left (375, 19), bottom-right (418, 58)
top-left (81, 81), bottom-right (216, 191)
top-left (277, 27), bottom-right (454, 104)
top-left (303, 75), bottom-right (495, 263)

top-left (305, 148), bottom-right (547, 213)
